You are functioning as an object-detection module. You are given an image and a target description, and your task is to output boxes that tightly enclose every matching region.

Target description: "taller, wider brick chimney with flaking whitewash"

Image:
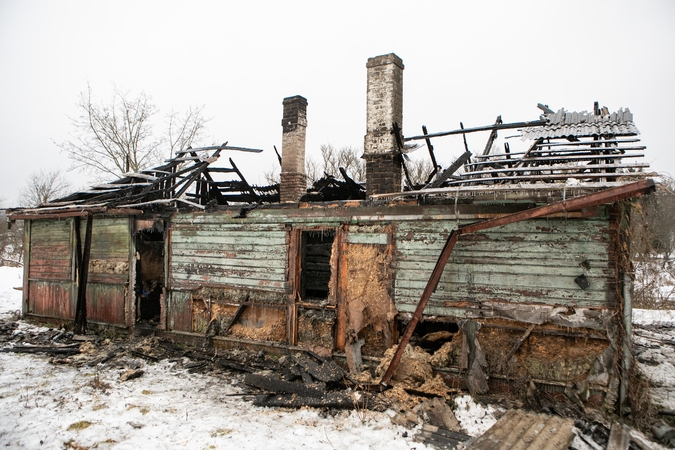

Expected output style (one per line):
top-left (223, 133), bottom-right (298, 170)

top-left (363, 53), bottom-right (403, 195)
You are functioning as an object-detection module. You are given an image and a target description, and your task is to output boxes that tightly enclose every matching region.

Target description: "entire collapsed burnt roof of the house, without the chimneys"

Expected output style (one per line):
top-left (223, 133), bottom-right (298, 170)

top-left (9, 103), bottom-right (654, 214)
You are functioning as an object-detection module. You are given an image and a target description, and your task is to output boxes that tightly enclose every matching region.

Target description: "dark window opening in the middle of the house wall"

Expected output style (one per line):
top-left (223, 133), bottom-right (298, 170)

top-left (300, 229), bottom-right (335, 303)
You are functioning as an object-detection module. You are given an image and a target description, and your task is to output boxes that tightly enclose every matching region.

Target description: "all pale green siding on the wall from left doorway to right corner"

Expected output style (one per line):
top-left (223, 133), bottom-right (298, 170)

top-left (171, 205), bottom-right (615, 315)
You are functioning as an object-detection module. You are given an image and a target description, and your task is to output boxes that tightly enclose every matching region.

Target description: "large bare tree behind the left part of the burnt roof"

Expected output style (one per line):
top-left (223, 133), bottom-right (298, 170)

top-left (56, 85), bottom-right (207, 178)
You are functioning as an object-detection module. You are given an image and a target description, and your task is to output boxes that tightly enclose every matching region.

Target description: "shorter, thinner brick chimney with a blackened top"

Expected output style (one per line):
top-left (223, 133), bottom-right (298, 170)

top-left (279, 95), bottom-right (307, 203)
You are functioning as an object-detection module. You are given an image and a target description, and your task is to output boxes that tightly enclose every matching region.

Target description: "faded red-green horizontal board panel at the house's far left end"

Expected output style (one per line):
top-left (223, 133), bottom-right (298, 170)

top-left (28, 219), bottom-right (73, 281)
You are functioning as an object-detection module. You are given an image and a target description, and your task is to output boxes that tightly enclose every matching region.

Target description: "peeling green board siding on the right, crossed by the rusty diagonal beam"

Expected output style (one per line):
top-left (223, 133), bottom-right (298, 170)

top-left (395, 219), bottom-right (613, 315)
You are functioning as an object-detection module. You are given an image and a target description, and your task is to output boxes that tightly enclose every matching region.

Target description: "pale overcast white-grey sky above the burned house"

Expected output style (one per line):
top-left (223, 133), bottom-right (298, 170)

top-left (0, 0), bottom-right (675, 206)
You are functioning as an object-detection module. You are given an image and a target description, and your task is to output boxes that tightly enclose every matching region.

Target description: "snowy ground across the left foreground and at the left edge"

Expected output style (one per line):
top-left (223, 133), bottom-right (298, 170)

top-left (0, 267), bottom-right (428, 450)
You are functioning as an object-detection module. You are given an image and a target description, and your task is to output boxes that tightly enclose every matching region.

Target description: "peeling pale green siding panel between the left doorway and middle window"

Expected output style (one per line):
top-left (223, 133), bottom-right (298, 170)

top-left (170, 214), bottom-right (288, 293)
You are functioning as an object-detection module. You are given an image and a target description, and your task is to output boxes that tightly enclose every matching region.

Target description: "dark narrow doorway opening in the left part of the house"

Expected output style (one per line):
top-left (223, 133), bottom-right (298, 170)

top-left (135, 221), bottom-right (164, 325)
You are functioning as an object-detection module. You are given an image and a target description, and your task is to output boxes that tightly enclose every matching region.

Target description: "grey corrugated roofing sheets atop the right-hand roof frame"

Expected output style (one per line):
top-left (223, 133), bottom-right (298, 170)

top-left (523, 109), bottom-right (640, 140)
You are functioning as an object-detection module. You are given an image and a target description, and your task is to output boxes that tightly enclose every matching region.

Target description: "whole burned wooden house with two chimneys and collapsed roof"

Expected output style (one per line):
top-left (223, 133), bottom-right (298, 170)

top-left (10, 54), bottom-right (654, 412)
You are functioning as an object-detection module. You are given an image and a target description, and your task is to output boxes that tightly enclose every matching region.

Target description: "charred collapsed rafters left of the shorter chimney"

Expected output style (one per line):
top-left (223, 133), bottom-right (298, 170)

top-left (17, 142), bottom-right (279, 214)
